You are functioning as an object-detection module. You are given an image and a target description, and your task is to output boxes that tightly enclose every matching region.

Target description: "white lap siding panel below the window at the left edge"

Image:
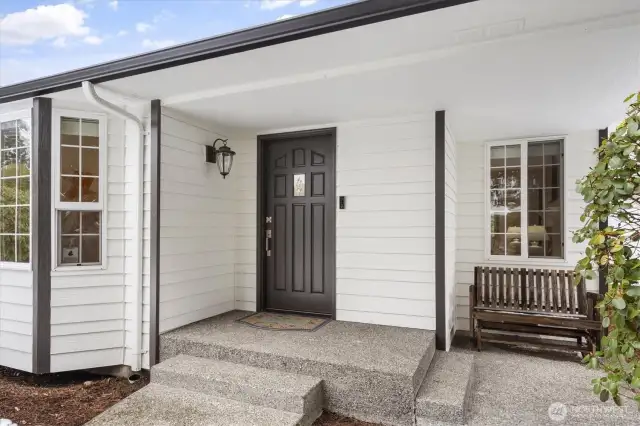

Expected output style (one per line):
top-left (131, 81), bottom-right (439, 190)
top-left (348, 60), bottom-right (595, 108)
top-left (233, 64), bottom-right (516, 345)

top-left (0, 269), bottom-right (33, 372)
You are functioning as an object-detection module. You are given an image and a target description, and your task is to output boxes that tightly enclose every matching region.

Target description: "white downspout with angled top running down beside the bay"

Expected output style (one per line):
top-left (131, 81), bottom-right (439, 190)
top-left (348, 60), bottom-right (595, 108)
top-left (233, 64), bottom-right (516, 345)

top-left (82, 81), bottom-right (147, 371)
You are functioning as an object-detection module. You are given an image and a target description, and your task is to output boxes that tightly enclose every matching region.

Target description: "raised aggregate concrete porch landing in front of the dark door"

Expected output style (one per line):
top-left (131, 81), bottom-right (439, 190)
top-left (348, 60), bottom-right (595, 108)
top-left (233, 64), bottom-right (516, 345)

top-left (160, 311), bottom-right (435, 425)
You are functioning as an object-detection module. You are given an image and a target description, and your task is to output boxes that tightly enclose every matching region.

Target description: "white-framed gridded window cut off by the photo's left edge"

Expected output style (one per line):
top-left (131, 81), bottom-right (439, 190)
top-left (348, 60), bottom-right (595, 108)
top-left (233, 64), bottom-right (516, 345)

top-left (0, 110), bottom-right (31, 265)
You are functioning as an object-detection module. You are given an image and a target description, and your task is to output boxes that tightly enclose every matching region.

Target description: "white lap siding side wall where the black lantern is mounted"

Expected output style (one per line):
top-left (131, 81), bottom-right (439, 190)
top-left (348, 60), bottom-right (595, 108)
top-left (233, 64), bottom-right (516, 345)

top-left (156, 109), bottom-right (237, 344)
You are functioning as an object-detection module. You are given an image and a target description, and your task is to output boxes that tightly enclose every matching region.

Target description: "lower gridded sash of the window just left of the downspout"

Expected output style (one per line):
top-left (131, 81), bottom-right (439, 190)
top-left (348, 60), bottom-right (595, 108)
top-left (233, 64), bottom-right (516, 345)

top-left (58, 210), bottom-right (102, 266)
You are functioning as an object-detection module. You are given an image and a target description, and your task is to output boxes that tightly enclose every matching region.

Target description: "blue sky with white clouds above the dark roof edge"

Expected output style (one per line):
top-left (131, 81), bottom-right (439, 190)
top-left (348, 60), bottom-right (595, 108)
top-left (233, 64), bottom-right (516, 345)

top-left (0, 0), bottom-right (353, 85)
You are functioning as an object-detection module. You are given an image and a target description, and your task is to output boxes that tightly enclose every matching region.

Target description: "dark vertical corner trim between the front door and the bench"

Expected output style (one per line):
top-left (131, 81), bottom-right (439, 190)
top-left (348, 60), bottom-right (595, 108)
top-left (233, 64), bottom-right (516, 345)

top-left (434, 111), bottom-right (447, 350)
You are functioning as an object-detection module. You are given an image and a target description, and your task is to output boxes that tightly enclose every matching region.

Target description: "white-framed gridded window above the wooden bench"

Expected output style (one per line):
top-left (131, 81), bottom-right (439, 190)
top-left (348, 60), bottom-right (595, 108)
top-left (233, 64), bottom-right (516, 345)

top-left (487, 139), bottom-right (564, 259)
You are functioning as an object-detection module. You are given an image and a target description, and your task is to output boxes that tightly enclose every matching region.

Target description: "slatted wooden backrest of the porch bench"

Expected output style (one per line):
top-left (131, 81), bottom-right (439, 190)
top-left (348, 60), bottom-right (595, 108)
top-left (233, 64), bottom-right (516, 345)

top-left (474, 266), bottom-right (587, 315)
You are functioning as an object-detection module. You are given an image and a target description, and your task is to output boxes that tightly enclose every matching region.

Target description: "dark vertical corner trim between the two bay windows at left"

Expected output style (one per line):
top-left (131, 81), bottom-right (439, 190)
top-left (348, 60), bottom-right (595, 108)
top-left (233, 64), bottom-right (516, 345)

top-left (31, 98), bottom-right (52, 374)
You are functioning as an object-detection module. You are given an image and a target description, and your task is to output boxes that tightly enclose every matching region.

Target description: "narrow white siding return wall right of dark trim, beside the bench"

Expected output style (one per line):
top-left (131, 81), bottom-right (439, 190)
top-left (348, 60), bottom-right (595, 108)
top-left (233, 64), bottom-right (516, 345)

top-left (444, 124), bottom-right (457, 348)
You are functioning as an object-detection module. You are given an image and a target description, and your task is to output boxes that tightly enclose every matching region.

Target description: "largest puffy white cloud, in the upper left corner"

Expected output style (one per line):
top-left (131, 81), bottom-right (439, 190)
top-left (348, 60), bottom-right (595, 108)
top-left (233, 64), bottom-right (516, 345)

top-left (0, 4), bottom-right (90, 45)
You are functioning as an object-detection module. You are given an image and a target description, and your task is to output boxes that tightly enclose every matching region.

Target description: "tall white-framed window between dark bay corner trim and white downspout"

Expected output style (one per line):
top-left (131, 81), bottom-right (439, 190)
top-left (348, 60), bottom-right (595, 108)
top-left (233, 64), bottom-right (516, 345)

top-left (54, 111), bottom-right (106, 267)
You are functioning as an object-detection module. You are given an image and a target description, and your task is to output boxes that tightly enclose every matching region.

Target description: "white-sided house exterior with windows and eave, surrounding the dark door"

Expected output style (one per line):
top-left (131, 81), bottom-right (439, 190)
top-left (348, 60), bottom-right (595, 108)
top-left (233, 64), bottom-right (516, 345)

top-left (0, 0), bottom-right (640, 373)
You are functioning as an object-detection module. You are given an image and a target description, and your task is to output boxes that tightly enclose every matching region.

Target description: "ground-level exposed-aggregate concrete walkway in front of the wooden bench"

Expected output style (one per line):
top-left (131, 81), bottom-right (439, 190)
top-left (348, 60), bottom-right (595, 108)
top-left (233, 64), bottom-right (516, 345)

top-left (453, 345), bottom-right (640, 426)
